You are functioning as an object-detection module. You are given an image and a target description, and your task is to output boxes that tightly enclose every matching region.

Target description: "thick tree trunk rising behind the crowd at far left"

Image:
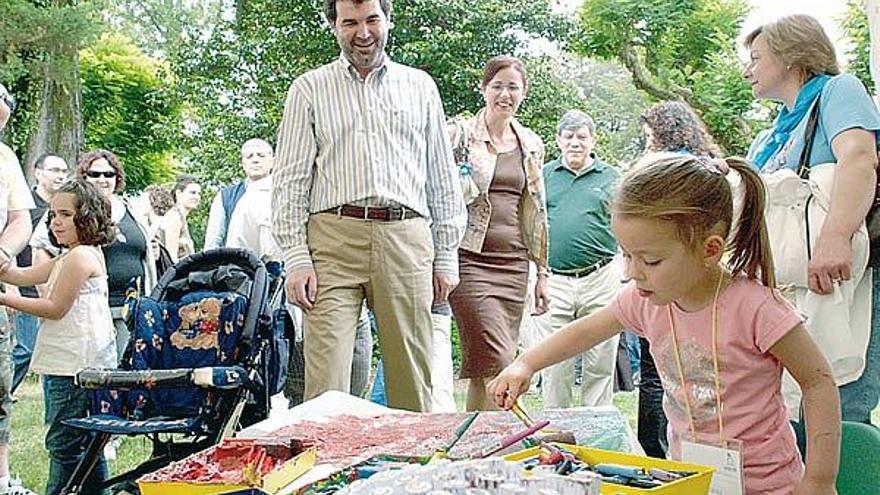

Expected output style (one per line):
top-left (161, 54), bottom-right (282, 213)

top-left (24, 46), bottom-right (83, 178)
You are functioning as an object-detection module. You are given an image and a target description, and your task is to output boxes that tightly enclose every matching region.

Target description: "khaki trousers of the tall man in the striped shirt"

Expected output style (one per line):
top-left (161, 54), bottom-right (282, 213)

top-left (303, 213), bottom-right (434, 411)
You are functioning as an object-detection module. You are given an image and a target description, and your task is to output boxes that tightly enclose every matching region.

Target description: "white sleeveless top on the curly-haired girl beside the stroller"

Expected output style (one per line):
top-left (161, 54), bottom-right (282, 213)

top-left (30, 246), bottom-right (117, 376)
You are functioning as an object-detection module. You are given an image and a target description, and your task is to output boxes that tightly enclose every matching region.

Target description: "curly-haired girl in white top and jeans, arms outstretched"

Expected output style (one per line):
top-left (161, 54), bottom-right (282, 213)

top-left (0, 180), bottom-right (117, 494)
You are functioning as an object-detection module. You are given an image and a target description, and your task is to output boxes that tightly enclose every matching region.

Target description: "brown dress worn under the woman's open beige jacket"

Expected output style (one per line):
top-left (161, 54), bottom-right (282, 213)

top-left (449, 148), bottom-right (529, 378)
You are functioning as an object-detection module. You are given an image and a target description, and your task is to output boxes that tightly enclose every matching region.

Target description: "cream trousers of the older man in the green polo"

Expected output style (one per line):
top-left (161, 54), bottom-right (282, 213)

top-left (536, 261), bottom-right (620, 408)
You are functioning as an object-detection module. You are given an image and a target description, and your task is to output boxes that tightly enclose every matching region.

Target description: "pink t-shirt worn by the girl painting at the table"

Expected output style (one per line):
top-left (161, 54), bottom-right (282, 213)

top-left (613, 276), bottom-right (803, 494)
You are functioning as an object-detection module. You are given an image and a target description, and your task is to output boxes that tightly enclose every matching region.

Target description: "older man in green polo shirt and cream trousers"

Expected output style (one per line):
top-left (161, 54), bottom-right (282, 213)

top-left (537, 110), bottom-right (621, 407)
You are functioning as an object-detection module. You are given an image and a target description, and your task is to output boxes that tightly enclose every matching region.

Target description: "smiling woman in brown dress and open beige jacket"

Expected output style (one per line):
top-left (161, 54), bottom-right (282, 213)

top-left (449, 56), bottom-right (549, 410)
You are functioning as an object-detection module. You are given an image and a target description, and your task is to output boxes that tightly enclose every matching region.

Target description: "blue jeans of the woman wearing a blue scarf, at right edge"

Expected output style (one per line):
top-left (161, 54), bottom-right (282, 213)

top-left (840, 268), bottom-right (880, 424)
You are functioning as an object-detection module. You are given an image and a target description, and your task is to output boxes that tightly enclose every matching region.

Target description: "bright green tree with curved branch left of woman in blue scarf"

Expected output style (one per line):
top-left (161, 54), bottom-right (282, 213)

top-left (576, 0), bottom-right (754, 153)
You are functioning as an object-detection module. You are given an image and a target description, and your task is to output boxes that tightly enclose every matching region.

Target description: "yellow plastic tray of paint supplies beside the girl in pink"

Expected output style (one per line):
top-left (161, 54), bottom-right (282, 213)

top-left (502, 444), bottom-right (715, 495)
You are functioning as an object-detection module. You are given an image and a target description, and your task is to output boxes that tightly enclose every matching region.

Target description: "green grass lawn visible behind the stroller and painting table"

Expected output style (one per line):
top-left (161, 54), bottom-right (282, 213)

top-left (10, 376), bottom-right (880, 493)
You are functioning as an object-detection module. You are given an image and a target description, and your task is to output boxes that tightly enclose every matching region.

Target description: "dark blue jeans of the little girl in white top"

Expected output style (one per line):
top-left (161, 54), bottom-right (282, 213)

top-left (43, 375), bottom-right (108, 495)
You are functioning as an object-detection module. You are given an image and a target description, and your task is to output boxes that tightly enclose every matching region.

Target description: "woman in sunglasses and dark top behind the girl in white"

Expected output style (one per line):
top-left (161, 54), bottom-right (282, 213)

top-left (31, 149), bottom-right (156, 358)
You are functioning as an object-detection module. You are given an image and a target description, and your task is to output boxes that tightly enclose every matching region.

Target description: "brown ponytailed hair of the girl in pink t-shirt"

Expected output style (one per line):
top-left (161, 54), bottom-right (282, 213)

top-left (611, 155), bottom-right (776, 288)
